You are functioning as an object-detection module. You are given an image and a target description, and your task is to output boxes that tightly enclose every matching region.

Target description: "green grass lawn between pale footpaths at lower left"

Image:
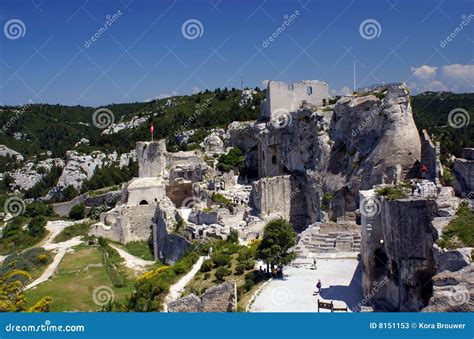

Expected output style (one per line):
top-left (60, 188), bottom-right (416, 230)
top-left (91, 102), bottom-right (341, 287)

top-left (25, 246), bottom-right (133, 312)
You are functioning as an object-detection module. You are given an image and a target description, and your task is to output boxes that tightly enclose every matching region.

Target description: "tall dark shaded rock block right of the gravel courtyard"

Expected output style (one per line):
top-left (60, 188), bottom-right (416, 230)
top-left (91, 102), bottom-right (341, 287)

top-left (360, 190), bottom-right (438, 311)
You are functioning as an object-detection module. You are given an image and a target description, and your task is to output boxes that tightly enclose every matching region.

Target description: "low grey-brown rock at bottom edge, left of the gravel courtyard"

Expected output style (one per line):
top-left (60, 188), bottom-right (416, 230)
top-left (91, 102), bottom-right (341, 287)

top-left (168, 282), bottom-right (237, 312)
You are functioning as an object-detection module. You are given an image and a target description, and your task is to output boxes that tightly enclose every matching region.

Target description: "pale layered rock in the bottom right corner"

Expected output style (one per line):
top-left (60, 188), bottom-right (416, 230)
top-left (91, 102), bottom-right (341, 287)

top-left (422, 264), bottom-right (474, 312)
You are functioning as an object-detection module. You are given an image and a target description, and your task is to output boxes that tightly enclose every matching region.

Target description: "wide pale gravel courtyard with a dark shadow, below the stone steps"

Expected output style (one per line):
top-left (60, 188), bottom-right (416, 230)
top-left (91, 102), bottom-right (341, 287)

top-left (250, 259), bottom-right (363, 312)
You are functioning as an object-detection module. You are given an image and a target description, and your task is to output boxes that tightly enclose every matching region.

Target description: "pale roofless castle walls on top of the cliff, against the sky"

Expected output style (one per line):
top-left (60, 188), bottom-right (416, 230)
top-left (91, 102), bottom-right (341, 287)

top-left (262, 80), bottom-right (329, 118)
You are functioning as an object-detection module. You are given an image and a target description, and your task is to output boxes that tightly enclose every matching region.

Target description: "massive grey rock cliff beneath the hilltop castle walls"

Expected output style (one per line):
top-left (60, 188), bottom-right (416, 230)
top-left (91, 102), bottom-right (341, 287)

top-left (254, 84), bottom-right (421, 222)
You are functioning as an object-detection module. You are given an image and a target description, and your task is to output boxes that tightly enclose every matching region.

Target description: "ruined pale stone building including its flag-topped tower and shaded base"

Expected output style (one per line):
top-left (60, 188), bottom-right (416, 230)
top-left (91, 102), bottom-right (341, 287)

top-left (89, 140), bottom-right (202, 263)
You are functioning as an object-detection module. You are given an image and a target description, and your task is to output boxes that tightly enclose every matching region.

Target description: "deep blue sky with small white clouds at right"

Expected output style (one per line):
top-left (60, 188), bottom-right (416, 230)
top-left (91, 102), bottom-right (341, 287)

top-left (0, 0), bottom-right (474, 106)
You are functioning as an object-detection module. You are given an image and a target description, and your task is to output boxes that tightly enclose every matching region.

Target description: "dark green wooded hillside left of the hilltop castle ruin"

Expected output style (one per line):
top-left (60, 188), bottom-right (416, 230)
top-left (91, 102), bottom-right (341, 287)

top-left (0, 88), bottom-right (264, 161)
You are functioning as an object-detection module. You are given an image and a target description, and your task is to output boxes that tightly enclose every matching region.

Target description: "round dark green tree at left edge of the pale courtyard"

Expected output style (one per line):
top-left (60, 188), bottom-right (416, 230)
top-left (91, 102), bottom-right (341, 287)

top-left (257, 218), bottom-right (296, 269)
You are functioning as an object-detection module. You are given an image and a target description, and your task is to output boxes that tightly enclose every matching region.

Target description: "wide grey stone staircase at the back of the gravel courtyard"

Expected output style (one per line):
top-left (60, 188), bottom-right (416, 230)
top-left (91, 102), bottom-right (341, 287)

top-left (294, 225), bottom-right (361, 258)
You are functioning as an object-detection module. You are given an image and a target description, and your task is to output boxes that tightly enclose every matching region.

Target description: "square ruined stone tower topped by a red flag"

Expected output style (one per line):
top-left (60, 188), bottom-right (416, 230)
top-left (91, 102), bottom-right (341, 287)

top-left (136, 139), bottom-right (167, 178)
